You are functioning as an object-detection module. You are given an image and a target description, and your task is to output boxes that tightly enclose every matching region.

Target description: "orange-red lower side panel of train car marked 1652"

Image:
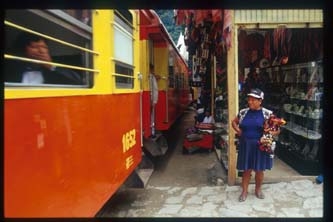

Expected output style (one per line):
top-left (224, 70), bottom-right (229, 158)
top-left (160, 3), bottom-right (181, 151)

top-left (4, 94), bottom-right (141, 217)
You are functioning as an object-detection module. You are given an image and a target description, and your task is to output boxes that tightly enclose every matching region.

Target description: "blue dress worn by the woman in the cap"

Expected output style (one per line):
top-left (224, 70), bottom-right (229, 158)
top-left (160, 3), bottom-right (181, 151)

top-left (237, 109), bottom-right (273, 171)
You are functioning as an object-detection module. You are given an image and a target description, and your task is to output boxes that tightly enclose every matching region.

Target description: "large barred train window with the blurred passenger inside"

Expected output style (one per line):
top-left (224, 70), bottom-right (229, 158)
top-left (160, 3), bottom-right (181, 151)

top-left (4, 10), bottom-right (94, 88)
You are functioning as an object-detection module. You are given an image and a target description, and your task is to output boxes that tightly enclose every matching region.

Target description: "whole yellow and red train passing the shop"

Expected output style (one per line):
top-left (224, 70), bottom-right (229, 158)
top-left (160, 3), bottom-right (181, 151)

top-left (3, 9), bottom-right (191, 218)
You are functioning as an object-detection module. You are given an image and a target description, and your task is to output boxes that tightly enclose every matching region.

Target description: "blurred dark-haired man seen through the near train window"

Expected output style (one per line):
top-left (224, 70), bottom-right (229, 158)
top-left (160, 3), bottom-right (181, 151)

top-left (5, 32), bottom-right (83, 85)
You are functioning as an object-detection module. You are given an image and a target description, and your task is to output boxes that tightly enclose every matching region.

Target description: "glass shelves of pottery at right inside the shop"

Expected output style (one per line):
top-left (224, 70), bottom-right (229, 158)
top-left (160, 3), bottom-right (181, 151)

top-left (266, 61), bottom-right (323, 175)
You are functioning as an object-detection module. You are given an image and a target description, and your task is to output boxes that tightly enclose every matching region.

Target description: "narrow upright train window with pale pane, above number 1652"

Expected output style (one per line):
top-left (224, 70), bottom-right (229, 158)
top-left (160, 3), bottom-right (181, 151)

top-left (114, 10), bottom-right (134, 89)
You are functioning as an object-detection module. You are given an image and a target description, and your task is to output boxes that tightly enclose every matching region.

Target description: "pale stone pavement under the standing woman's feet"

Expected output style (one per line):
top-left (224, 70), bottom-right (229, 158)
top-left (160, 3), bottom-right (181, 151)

top-left (100, 179), bottom-right (323, 218)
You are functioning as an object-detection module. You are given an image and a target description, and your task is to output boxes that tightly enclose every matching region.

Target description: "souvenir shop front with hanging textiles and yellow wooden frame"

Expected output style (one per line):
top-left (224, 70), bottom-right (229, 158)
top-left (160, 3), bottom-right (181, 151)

top-left (176, 10), bottom-right (323, 185)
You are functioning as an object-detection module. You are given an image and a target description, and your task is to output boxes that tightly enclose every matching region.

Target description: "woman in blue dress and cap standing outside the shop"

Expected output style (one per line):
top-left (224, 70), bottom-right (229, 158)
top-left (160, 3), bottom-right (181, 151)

top-left (232, 88), bottom-right (279, 202)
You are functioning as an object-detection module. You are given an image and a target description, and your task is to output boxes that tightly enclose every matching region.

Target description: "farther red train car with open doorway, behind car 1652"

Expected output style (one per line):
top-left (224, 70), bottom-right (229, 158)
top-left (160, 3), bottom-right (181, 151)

top-left (140, 10), bottom-right (191, 156)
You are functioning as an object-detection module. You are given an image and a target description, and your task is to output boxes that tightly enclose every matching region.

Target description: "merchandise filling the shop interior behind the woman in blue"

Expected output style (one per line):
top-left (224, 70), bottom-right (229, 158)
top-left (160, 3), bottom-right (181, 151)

top-left (238, 26), bottom-right (324, 175)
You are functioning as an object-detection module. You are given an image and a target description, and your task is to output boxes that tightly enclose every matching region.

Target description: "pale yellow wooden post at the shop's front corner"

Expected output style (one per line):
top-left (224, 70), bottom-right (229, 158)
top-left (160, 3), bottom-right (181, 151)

top-left (227, 10), bottom-right (238, 186)
